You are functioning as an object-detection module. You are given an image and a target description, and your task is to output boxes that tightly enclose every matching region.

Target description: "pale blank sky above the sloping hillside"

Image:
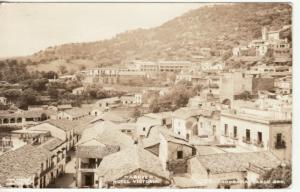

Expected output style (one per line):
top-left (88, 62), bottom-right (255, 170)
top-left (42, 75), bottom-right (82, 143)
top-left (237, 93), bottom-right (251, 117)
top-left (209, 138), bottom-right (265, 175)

top-left (0, 3), bottom-right (204, 58)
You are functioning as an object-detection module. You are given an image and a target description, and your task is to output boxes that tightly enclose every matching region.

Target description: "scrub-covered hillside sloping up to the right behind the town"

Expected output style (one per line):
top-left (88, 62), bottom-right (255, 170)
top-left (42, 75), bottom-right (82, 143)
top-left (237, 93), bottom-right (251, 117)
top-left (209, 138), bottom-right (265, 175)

top-left (4, 3), bottom-right (292, 70)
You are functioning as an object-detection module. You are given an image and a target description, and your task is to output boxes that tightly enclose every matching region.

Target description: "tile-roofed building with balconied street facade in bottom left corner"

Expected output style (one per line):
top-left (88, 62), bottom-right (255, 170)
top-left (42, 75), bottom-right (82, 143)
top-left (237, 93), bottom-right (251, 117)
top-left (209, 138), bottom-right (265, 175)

top-left (0, 130), bottom-right (66, 188)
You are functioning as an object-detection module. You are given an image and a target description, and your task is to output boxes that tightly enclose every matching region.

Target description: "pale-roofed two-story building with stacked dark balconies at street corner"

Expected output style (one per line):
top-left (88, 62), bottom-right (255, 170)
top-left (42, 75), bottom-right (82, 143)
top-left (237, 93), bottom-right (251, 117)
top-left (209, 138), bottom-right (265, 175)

top-left (76, 121), bottom-right (133, 187)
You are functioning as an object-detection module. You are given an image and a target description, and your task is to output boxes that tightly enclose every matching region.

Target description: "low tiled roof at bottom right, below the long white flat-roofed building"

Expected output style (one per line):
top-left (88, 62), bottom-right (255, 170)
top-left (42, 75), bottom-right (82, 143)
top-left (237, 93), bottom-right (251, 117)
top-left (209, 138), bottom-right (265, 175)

top-left (195, 151), bottom-right (280, 174)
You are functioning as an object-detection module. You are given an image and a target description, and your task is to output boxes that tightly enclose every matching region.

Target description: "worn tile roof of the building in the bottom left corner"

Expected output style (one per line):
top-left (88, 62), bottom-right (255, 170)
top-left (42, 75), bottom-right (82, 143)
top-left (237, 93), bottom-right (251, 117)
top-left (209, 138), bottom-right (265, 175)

top-left (0, 144), bottom-right (52, 185)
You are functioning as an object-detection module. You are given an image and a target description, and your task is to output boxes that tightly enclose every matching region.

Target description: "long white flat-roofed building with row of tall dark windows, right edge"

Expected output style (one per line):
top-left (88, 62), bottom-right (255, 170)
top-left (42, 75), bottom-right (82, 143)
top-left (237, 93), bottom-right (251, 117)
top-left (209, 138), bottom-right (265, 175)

top-left (220, 108), bottom-right (292, 160)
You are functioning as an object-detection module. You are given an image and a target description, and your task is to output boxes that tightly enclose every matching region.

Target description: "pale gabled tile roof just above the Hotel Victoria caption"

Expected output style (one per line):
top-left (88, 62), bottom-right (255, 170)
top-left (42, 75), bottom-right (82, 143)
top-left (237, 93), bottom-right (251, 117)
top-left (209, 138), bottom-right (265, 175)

top-left (97, 145), bottom-right (169, 182)
